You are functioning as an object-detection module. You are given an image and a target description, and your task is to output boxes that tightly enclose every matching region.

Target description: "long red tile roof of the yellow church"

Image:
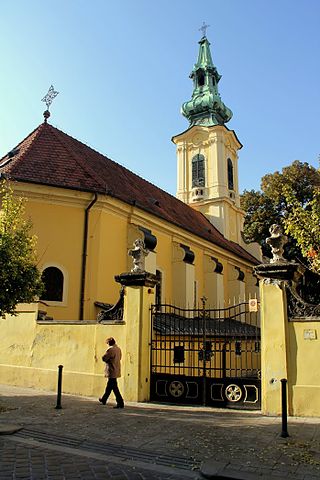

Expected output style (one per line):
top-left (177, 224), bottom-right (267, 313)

top-left (0, 123), bottom-right (258, 264)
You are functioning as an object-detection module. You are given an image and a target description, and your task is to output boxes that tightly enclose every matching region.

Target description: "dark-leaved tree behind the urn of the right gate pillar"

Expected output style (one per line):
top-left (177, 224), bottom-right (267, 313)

top-left (241, 160), bottom-right (320, 259)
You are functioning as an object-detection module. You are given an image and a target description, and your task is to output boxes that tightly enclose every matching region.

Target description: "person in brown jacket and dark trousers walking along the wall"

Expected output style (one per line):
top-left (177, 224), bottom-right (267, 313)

top-left (99, 337), bottom-right (124, 408)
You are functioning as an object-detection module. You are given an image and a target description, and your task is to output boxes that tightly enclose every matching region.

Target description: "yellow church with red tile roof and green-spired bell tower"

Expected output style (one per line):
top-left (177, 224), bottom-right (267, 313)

top-left (0, 32), bottom-right (260, 322)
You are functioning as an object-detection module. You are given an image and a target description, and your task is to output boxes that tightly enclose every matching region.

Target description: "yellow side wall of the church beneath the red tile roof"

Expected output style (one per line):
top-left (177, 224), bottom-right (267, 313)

top-left (10, 184), bottom-right (258, 320)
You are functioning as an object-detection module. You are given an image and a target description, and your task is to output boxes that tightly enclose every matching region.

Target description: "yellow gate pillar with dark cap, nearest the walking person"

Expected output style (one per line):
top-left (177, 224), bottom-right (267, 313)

top-left (115, 272), bottom-right (157, 402)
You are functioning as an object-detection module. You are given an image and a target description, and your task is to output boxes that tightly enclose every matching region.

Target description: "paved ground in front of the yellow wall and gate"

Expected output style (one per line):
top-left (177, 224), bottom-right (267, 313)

top-left (0, 385), bottom-right (320, 480)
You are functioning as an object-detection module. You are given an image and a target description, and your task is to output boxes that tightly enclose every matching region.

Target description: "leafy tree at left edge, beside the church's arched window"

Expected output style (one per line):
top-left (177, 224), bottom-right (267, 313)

top-left (0, 181), bottom-right (43, 316)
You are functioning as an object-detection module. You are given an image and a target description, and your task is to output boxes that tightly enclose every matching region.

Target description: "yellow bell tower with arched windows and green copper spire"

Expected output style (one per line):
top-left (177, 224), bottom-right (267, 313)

top-left (172, 35), bottom-right (244, 244)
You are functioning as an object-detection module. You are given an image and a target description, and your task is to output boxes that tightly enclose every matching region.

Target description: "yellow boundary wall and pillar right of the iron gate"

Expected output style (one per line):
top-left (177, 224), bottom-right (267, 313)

top-left (260, 281), bottom-right (320, 417)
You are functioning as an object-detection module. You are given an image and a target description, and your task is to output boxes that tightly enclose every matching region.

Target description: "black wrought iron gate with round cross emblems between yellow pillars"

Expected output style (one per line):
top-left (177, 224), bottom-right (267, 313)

top-left (151, 303), bottom-right (261, 409)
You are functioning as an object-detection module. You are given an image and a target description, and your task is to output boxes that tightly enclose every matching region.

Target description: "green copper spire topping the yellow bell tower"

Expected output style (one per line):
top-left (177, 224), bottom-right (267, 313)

top-left (181, 36), bottom-right (232, 127)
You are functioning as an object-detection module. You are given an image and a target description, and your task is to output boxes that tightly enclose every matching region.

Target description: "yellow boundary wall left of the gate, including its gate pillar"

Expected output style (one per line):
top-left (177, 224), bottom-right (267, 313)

top-left (0, 287), bottom-right (154, 401)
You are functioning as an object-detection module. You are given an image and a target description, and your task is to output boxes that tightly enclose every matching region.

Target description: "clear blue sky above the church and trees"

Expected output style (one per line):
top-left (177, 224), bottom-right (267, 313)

top-left (0, 0), bottom-right (320, 194)
